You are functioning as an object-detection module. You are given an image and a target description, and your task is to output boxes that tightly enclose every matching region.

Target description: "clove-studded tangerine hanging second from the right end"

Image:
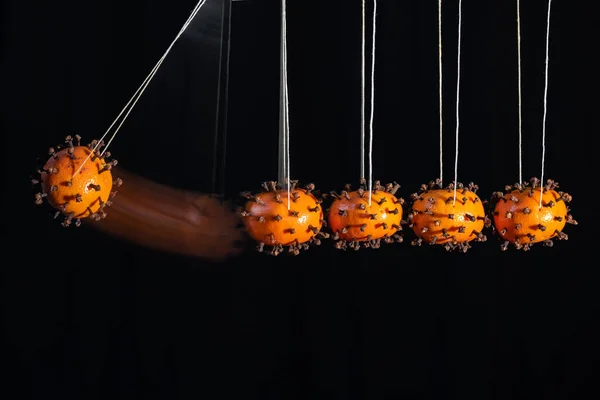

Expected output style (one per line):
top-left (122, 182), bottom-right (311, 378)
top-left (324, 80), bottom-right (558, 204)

top-left (408, 179), bottom-right (491, 252)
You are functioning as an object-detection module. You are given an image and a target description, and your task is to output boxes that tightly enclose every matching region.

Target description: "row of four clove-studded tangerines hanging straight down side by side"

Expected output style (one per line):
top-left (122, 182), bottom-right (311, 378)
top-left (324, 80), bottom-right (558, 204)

top-left (239, 178), bottom-right (577, 255)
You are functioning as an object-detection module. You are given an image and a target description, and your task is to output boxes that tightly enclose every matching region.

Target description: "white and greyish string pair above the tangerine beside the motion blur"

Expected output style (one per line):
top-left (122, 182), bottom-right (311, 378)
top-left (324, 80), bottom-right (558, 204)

top-left (278, 0), bottom-right (292, 210)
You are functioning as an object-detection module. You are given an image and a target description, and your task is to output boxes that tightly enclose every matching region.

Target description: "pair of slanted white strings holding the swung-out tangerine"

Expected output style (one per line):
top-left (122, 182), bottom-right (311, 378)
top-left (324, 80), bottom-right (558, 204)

top-left (73, 0), bottom-right (206, 177)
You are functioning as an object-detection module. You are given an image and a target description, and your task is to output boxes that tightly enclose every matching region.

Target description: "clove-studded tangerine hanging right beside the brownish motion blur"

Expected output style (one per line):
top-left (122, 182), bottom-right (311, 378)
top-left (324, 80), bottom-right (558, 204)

top-left (239, 181), bottom-right (329, 255)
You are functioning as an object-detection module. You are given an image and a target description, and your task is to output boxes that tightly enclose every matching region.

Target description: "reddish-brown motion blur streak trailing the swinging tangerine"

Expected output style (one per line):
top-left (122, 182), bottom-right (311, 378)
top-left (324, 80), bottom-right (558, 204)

top-left (92, 168), bottom-right (244, 261)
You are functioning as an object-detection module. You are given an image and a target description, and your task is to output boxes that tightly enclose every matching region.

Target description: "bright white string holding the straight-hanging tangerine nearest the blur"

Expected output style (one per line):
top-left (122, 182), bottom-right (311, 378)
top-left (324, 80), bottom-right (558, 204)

top-left (281, 0), bottom-right (292, 210)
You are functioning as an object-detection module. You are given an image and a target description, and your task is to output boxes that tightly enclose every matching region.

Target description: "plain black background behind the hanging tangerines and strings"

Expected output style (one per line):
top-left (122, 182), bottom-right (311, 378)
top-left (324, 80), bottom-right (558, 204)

top-left (0, 0), bottom-right (600, 400)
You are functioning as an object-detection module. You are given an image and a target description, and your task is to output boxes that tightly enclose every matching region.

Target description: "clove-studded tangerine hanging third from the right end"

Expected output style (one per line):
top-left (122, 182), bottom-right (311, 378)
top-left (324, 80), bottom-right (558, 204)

top-left (328, 180), bottom-right (404, 250)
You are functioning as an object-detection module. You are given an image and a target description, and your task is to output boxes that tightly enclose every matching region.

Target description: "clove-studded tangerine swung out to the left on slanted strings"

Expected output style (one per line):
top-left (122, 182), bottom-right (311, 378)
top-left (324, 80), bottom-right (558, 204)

top-left (32, 135), bottom-right (122, 227)
